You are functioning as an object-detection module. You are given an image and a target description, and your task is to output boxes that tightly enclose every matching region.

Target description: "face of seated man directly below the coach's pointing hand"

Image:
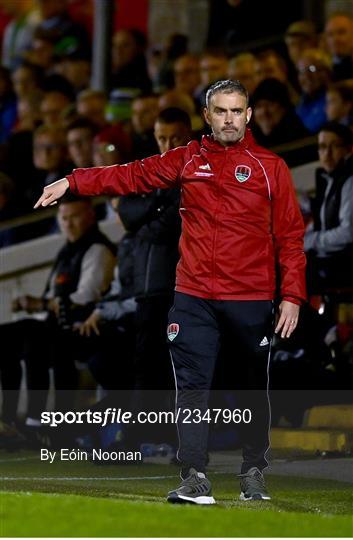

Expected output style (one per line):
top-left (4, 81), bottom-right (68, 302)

top-left (58, 201), bottom-right (95, 242)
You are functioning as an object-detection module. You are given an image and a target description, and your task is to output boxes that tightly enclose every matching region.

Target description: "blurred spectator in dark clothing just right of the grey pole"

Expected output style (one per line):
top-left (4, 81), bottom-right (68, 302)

top-left (112, 29), bottom-right (151, 94)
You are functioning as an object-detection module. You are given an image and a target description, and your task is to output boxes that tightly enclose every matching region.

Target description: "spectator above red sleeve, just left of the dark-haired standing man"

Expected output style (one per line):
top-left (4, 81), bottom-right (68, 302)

top-left (131, 96), bottom-right (158, 159)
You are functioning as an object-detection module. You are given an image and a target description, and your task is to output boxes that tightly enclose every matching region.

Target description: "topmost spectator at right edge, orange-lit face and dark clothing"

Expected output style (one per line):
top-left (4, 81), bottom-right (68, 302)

top-left (325, 13), bottom-right (353, 81)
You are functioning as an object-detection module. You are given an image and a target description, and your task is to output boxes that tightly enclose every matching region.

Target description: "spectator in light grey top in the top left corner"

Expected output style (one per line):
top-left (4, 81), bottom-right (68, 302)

top-left (1, 0), bottom-right (40, 70)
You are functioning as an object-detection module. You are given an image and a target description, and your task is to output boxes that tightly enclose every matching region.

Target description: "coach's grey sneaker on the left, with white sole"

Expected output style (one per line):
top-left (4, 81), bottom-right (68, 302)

top-left (167, 469), bottom-right (216, 504)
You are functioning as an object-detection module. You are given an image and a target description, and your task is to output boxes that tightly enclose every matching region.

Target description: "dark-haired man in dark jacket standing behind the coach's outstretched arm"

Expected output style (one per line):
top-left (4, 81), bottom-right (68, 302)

top-left (118, 108), bottom-right (191, 390)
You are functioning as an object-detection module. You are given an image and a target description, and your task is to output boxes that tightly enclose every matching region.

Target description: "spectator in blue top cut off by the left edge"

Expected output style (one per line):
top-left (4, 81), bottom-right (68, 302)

top-left (0, 66), bottom-right (17, 144)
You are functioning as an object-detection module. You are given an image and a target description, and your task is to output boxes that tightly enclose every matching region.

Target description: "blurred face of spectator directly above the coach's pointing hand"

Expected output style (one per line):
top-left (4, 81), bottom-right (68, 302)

top-left (33, 133), bottom-right (66, 172)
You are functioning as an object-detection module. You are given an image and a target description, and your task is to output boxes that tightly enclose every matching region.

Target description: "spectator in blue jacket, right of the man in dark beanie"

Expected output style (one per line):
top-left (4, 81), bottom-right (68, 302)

top-left (296, 49), bottom-right (332, 133)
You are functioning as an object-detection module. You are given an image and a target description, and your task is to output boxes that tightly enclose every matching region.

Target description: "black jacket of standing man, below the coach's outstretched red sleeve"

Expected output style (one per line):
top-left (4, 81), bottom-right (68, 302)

top-left (119, 188), bottom-right (181, 298)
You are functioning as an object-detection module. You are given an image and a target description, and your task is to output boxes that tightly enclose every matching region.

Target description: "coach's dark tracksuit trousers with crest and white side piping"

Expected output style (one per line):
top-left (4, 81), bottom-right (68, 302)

top-left (168, 293), bottom-right (273, 473)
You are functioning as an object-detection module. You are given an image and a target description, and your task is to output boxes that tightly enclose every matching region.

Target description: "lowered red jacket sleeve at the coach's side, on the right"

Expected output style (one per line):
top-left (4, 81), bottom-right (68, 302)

top-left (272, 159), bottom-right (306, 304)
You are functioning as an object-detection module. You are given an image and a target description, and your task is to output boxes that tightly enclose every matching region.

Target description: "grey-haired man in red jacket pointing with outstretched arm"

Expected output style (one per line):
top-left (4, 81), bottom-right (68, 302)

top-left (36, 80), bottom-right (306, 504)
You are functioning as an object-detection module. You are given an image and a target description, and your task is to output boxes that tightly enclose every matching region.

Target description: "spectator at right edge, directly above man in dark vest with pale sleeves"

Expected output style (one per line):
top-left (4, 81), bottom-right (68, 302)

top-left (326, 81), bottom-right (353, 128)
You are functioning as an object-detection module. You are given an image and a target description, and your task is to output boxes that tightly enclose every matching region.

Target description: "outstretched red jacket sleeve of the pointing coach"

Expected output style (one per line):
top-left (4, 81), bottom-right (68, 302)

top-left (67, 146), bottom-right (187, 195)
